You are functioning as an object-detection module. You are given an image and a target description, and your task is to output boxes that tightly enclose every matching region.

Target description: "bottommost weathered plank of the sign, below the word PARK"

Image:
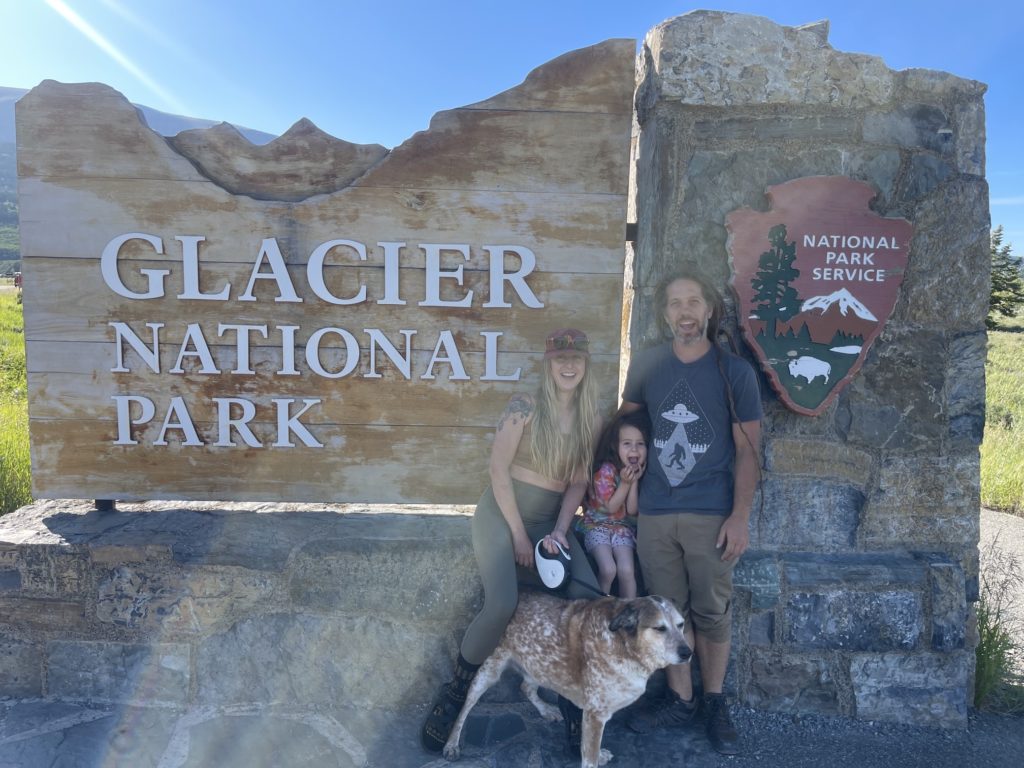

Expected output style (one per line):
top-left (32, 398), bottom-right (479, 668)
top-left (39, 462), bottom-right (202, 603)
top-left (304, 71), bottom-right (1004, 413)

top-left (32, 421), bottom-right (494, 504)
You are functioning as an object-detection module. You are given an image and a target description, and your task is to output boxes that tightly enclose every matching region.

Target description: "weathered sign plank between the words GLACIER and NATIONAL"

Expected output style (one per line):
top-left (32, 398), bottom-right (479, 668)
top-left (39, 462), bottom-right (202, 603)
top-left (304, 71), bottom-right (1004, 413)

top-left (24, 259), bottom-right (622, 353)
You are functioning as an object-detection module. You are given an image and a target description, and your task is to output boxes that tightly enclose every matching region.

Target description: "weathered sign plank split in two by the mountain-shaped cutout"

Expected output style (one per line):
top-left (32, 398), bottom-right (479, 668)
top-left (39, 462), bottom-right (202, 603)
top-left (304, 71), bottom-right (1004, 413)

top-left (17, 94), bottom-right (630, 195)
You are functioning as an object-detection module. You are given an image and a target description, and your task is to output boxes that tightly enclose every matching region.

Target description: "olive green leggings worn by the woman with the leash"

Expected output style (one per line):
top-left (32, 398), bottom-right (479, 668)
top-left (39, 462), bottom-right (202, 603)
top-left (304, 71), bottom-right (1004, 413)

top-left (461, 480), bottom-right (601, 664)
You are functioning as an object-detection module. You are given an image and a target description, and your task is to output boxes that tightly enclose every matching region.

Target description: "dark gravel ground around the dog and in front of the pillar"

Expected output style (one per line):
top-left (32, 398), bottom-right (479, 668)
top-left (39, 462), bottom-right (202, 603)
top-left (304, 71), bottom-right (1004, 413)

top-left (419, 705), bottom-right (1024, 768)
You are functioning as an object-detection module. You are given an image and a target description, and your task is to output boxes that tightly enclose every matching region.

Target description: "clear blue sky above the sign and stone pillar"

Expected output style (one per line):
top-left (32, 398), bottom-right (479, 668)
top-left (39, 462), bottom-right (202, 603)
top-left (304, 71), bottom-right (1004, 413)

top-left (8, 0), bottom-right (1024, 246)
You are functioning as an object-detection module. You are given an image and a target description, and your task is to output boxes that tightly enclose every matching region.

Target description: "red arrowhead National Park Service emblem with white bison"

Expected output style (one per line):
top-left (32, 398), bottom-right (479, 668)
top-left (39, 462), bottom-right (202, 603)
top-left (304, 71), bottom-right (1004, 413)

top-left (725, 176), bottom-right (913, 416)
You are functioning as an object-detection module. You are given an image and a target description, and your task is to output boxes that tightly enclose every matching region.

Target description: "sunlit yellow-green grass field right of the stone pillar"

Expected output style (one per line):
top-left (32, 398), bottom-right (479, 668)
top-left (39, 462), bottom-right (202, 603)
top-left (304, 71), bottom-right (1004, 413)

top-left (981, 325), bottom-right (1024, 516)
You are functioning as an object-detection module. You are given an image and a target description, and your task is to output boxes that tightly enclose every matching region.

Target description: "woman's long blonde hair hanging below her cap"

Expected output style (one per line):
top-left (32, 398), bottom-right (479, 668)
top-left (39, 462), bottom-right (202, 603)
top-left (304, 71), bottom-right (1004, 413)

top-left (529, 357), bottom-right (599, 482)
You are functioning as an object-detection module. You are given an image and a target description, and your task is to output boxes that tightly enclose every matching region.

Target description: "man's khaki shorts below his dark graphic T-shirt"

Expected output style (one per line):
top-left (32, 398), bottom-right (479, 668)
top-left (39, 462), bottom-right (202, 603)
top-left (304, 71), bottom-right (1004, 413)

top-left (637, 512), bottom-right (736, 643)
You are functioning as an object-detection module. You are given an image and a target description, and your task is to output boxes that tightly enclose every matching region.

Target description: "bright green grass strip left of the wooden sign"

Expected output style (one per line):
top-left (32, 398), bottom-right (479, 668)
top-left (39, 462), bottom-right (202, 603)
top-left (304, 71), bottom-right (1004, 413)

top-left (0, 291), bottom-right (32, 515)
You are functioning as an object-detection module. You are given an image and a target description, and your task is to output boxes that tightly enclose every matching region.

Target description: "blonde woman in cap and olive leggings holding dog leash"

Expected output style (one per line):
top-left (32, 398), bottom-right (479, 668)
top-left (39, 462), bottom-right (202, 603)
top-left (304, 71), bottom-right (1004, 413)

top-left (422, 328), bottom-right (600, 752)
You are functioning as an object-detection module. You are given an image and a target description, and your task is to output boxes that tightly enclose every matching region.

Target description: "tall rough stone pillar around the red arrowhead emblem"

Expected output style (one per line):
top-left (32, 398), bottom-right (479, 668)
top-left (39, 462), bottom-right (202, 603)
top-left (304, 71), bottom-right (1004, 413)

top-left (629, 11), bottom-right (989, 726)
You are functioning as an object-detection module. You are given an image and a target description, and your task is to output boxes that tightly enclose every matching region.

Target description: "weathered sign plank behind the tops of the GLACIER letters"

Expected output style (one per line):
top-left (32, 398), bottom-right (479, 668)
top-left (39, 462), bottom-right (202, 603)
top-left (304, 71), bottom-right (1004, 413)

top-left (18, 178), bottom-right (626, 273)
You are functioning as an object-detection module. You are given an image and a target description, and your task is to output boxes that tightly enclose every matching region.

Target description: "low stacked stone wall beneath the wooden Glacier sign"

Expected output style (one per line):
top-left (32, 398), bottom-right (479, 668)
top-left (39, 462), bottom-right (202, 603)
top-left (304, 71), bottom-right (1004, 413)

top-left (0, 501), bottom-right (480, 711)
